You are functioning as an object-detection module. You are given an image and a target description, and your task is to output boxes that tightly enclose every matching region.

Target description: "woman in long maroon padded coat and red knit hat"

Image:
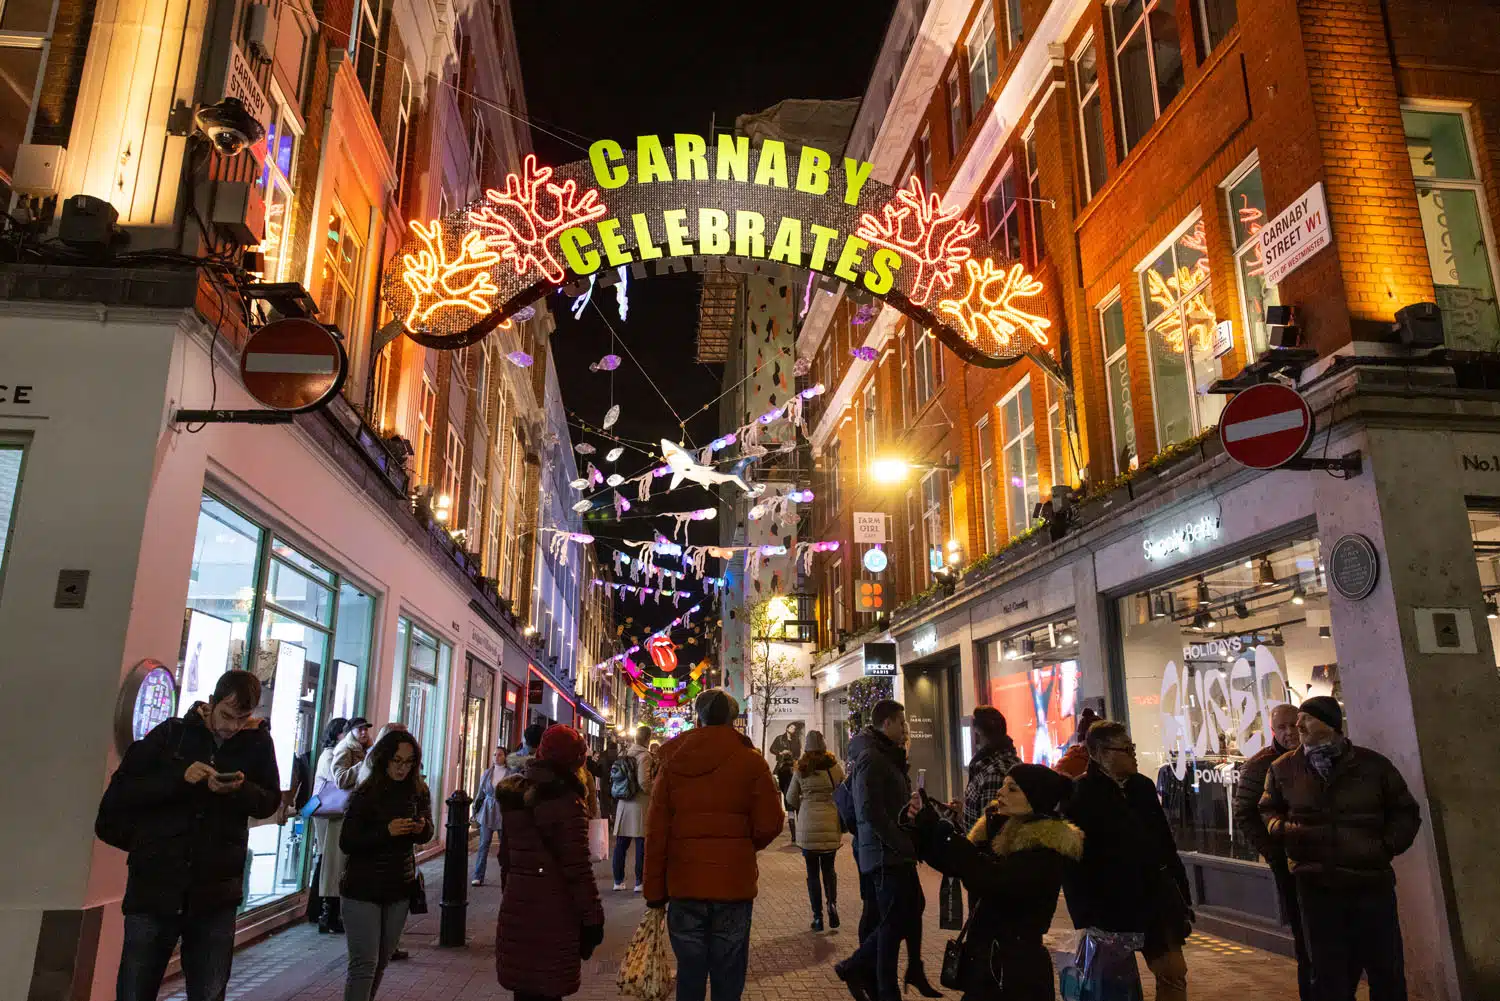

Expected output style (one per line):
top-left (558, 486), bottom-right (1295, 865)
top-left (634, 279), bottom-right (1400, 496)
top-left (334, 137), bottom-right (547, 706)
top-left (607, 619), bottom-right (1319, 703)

top-left (495, 726), bottom-right (605, 1001)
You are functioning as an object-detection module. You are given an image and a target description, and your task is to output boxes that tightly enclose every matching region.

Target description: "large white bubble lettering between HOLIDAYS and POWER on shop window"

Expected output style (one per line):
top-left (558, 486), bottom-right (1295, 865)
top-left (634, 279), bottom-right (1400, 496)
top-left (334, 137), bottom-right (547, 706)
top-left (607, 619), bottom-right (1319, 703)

top-left (1161, 636), bottom-right (1289, 779)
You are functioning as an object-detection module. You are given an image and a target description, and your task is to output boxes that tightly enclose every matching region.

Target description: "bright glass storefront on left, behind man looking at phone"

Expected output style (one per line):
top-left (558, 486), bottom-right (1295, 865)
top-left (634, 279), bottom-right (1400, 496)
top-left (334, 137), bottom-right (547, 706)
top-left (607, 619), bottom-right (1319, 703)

top-left (179, 494), bottom-right (375, 909)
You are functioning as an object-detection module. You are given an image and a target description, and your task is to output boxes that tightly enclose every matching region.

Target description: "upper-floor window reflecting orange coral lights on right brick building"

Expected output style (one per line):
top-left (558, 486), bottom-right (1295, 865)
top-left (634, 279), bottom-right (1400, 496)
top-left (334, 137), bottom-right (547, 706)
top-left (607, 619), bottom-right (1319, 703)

top-left (1140, 218), bottom-right (1224, 449)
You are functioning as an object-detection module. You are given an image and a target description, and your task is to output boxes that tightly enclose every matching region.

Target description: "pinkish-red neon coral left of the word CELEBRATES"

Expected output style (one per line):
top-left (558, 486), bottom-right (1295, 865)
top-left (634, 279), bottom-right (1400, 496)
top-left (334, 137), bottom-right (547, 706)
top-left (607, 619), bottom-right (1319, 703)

top-left (468, 153), bottom-right (606, 285)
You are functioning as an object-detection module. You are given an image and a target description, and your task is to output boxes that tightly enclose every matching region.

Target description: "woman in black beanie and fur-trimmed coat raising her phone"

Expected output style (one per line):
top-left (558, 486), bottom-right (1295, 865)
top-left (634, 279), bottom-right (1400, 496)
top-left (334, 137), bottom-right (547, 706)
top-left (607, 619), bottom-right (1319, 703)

top-left (915, 764), bottom-right (1083, 1001)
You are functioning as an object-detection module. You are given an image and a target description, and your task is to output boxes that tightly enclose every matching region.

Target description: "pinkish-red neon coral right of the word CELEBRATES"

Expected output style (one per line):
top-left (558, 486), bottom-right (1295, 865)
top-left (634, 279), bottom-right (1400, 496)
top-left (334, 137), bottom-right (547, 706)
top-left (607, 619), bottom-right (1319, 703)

top-left (855, 177), bottom-right (980, 306)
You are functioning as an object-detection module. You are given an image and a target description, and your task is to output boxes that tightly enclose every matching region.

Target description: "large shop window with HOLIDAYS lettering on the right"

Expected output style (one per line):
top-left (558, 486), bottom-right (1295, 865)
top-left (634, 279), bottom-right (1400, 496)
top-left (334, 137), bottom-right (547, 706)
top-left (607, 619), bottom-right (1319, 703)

top-left (1119, 539), bottom-right (1338, 861)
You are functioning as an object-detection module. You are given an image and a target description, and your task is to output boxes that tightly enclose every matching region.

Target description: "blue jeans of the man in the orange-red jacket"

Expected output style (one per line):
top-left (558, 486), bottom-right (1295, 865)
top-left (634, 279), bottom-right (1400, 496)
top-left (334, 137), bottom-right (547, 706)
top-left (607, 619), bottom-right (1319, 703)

top-left (666, 900), bottom-right (755, 1001)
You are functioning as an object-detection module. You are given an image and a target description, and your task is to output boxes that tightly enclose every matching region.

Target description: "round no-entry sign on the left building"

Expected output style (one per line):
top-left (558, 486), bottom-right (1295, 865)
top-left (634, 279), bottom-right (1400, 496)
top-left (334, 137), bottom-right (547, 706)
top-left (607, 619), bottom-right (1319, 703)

top-left (240, 317), bottom-right (350, 411)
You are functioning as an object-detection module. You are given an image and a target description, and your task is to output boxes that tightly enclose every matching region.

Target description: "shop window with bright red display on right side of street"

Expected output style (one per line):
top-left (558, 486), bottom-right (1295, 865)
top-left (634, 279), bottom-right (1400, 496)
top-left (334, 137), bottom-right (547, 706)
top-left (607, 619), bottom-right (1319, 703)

top-left (981, 614), bottom-right (1082, 765)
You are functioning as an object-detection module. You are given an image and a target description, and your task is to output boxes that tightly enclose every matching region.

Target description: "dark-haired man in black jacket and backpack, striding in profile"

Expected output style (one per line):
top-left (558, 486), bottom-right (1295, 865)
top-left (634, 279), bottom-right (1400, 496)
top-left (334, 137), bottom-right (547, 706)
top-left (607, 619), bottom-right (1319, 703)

top-left (834, 699), bottom-right (924, 1001)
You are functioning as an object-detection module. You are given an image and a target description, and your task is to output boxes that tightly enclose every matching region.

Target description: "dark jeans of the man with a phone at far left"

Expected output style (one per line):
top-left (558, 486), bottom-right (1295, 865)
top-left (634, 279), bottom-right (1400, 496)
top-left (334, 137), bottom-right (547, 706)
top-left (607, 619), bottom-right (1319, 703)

top-left (116, 906), bottom-right (236, 1001)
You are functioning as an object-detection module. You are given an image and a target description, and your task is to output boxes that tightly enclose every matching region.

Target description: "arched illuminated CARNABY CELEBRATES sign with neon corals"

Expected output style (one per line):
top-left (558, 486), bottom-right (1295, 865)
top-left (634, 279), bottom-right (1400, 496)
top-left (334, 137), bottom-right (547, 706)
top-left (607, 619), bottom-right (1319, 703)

top-left (384, 132), bottom-right (1052, 366)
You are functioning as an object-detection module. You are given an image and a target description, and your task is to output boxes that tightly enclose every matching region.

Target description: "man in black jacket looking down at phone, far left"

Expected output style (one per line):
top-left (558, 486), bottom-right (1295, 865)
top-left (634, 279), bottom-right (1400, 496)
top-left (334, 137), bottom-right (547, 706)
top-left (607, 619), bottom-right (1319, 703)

top-left (95, 671), bottom-right (281, 1001)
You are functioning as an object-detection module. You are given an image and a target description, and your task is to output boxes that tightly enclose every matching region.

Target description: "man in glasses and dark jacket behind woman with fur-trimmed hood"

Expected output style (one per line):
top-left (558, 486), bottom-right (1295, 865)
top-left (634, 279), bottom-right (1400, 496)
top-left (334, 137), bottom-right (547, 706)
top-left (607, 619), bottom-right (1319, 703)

top-left (1064, 722), bottom-right (1193, 1001)
